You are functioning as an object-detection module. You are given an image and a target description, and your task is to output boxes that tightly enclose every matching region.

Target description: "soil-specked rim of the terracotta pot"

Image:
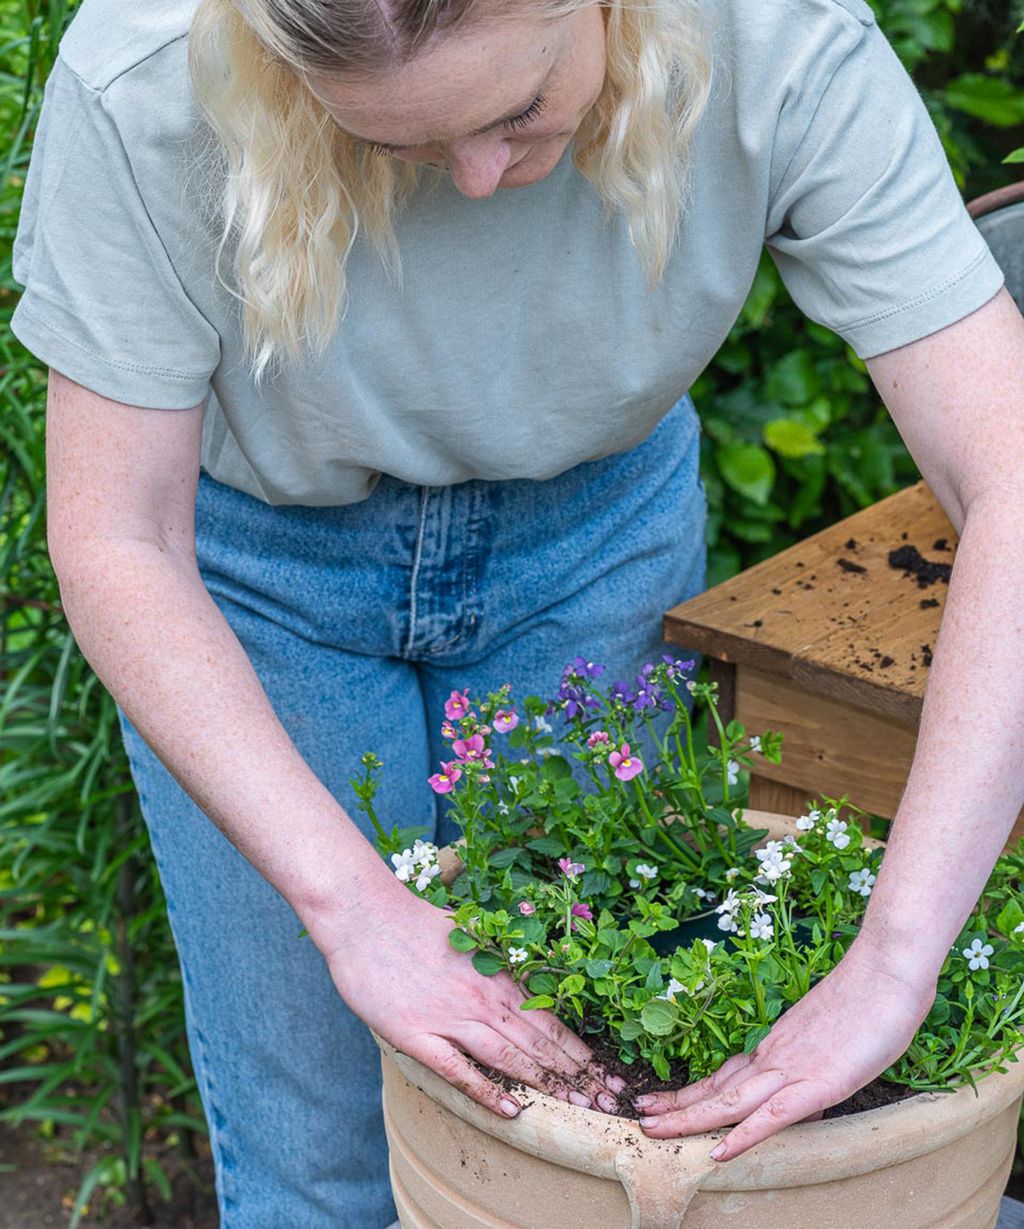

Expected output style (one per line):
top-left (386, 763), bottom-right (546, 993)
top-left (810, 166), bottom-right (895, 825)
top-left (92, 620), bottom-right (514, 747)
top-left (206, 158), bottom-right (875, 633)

top-left (381, 810), bottom-right (1024, 1191)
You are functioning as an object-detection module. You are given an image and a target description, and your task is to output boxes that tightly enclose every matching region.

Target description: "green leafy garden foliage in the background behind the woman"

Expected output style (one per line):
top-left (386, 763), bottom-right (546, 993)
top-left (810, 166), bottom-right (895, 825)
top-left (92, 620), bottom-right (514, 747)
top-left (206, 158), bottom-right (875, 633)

top-left (0, 0), bottom-right (1024, 1224)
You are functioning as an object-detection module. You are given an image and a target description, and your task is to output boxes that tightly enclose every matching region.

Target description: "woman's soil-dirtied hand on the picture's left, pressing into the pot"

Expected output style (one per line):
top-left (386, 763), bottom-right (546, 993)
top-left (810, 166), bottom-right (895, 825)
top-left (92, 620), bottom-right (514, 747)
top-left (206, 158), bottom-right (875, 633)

top-left (321, 884), bottom-right (624, 1117)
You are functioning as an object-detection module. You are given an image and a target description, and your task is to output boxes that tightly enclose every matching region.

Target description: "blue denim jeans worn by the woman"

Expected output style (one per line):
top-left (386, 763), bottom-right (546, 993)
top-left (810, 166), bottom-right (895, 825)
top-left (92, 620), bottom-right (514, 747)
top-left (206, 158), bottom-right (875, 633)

top-left (111, 396), bottom-right (704, 1229)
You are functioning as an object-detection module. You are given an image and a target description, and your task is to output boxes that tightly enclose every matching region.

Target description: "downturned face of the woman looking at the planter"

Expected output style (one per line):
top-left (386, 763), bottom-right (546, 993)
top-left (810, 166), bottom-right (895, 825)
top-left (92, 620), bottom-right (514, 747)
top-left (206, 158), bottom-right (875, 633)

top-left (309, 4), bottom-right (605, 198)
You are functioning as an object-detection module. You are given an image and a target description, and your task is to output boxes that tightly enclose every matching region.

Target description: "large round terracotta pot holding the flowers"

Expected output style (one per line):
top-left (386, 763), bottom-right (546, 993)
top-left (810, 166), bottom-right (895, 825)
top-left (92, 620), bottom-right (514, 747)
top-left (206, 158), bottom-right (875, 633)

top-left (376, 811), bottom-right (1024, 1229)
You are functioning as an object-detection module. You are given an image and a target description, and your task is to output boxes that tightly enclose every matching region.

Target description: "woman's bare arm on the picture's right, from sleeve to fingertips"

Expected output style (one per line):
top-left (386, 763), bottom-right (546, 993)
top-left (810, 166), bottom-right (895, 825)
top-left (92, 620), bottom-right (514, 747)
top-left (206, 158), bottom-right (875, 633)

top-left (637, 288), bottom-right (1024, 1160)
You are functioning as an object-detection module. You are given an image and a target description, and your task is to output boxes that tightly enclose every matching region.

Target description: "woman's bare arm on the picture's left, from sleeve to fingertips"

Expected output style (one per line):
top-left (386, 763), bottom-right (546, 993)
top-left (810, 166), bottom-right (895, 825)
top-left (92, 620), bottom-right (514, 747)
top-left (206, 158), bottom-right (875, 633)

top-left (47, 369), bottom-right (617, 1113)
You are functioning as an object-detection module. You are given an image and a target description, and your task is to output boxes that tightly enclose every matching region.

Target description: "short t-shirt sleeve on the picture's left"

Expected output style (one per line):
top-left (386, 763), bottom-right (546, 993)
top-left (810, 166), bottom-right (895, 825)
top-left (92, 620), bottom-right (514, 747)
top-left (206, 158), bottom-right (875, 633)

top-left (11, 57), bottom-right (220, 409)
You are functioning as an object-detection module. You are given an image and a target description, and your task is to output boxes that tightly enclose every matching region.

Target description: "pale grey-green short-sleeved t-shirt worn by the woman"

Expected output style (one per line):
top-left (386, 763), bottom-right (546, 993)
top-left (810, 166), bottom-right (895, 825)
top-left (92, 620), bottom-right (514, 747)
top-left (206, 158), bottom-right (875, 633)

top-left (11, 0), bottom-right (1004, 504)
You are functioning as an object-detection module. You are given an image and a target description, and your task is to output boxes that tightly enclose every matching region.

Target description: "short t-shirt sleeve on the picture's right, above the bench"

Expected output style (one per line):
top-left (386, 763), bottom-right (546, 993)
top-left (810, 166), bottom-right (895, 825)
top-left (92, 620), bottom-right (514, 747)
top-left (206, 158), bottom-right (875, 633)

top-left (766, 10), bottom-right (1004, 359)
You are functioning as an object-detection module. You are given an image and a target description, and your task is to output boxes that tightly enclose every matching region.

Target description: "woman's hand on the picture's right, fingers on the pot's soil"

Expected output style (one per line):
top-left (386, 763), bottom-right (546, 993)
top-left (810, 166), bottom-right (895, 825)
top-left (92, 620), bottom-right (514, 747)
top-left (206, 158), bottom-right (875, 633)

top-left (634, 934), bottom-right (938, 1160)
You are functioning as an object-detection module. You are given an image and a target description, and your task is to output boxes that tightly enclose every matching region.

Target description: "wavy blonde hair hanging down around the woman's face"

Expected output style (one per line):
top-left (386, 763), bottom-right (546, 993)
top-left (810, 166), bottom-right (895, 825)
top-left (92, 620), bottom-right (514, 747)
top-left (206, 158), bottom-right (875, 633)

top-left (188, 0), bottom-right (712, 383)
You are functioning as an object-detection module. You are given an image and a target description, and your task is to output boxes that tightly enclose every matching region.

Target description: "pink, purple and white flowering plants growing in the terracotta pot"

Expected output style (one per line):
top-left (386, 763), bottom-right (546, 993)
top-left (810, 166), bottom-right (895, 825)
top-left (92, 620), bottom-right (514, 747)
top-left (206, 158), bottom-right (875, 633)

top-left (354, 656), bottom-right (1024, 1090)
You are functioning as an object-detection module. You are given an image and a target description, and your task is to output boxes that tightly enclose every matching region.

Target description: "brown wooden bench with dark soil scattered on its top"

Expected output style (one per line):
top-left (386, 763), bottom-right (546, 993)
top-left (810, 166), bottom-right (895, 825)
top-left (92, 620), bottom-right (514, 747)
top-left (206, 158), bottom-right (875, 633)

top-left (665, 482), bottom-right (1024, 844)
